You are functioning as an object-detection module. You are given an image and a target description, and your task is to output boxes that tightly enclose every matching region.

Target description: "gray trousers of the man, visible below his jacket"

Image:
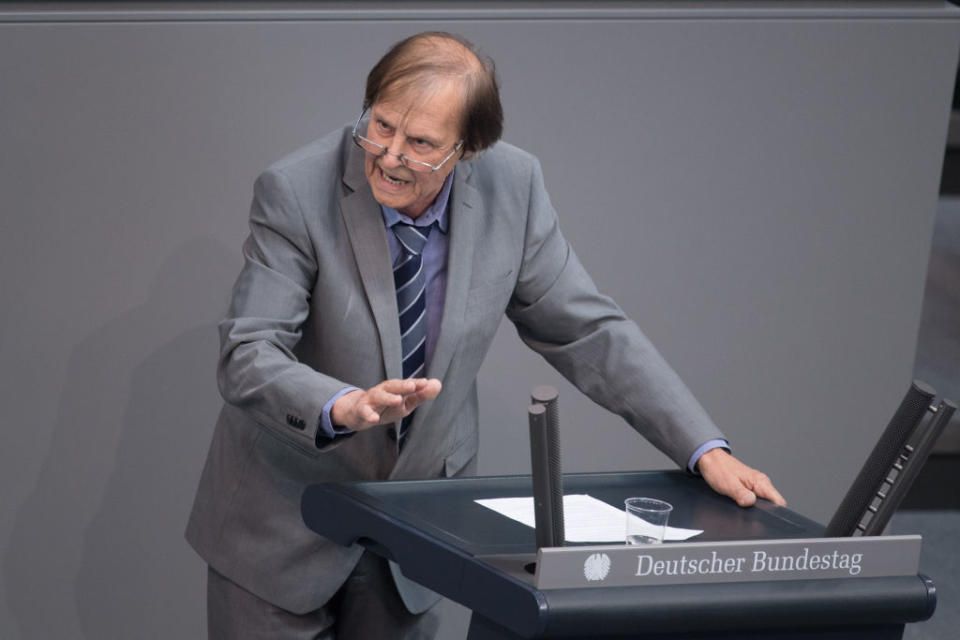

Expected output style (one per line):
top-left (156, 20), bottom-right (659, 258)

top-left (207, 552), bottom-right (440, 640)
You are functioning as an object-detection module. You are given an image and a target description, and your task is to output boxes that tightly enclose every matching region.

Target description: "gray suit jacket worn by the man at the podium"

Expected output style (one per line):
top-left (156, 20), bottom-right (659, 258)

top-left (187, 129), bottom-right (721, 613)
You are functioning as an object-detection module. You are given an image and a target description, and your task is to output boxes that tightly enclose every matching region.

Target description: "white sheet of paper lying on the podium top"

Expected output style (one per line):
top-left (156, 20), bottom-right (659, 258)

top-left (475, 494), bottom-right (703, 542)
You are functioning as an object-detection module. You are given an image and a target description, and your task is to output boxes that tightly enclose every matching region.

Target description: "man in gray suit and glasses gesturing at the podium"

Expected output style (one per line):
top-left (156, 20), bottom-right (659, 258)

top-left (187, 33), bottom-right (784, 639)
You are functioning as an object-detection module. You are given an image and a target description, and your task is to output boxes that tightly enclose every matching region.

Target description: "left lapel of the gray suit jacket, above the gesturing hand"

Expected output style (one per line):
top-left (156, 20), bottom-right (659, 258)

top-left (340, 145), bottom-right (403, 378)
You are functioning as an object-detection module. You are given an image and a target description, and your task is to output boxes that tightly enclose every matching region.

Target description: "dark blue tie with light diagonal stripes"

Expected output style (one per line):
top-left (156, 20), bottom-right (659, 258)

top-left (393, 222), bottom-right (433, 443)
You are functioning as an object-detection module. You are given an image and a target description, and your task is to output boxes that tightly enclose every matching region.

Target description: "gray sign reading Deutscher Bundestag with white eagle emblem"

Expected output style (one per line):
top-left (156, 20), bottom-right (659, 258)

top-left (536, 536), bottom-right (921, 589)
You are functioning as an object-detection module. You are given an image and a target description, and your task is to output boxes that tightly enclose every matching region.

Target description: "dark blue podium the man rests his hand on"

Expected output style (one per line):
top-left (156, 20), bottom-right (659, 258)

top-left (301, 471), bottom-right (936, 640)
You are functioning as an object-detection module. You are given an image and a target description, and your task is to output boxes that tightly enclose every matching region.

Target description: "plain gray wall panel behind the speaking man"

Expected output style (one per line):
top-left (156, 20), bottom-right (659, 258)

top-left (0, 3), bottom-right (960, 640)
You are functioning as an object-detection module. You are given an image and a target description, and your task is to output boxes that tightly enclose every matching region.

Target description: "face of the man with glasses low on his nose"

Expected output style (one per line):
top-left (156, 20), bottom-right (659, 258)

top-left (364, 82), bottom-right (463, 218)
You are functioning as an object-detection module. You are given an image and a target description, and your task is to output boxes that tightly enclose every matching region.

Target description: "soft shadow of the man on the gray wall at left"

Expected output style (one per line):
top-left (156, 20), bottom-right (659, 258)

top-left (3, 239), bottom-right (236, 640)
